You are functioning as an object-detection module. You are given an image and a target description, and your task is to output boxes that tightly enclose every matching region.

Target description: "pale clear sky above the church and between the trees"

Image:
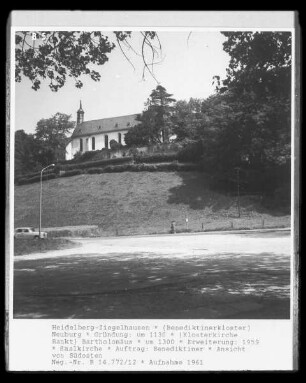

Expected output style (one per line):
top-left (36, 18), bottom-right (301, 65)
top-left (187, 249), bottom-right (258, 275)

top-left (15, 31), bottom-right (229, 133)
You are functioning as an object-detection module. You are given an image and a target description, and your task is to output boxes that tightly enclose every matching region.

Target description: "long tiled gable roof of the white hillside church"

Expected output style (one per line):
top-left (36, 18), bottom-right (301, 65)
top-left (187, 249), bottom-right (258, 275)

top-left (71, 114), bottom-right (139, 138)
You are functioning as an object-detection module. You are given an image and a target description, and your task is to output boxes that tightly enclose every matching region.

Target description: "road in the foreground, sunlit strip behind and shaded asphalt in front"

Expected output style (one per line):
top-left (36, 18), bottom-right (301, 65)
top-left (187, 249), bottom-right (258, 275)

top-left (14, 231), bottom-right (290, 319)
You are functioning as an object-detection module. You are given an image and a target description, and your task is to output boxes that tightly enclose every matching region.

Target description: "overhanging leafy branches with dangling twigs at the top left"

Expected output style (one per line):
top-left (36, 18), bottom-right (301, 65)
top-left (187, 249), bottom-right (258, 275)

top-left (15, 31), bottom-right (161, 92)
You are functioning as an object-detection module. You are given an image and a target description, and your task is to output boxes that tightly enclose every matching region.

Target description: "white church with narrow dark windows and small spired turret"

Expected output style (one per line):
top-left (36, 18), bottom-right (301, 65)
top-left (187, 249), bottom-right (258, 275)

top-left (66, 101), bottom-right (139, 160)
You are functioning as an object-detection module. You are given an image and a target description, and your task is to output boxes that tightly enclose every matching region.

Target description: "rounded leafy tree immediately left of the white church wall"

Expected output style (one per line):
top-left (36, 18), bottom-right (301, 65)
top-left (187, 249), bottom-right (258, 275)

top-left (35, 113), bottom-right (75, 165)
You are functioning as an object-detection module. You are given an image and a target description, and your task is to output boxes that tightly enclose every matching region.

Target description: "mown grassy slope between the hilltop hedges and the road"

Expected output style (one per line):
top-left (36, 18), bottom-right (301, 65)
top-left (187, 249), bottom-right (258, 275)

top-left (15, 172), bottom-right (290, 235)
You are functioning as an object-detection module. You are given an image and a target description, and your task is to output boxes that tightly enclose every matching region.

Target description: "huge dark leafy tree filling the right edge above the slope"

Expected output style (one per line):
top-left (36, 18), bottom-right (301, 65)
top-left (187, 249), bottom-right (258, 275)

top-left (203, 32), bottom-right (291, 198)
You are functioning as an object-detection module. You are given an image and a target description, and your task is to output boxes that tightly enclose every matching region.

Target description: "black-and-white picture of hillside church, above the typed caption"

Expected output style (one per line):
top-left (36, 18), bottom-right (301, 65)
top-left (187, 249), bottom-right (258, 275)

top-left (6, 11), bottom-right (294, 372)
